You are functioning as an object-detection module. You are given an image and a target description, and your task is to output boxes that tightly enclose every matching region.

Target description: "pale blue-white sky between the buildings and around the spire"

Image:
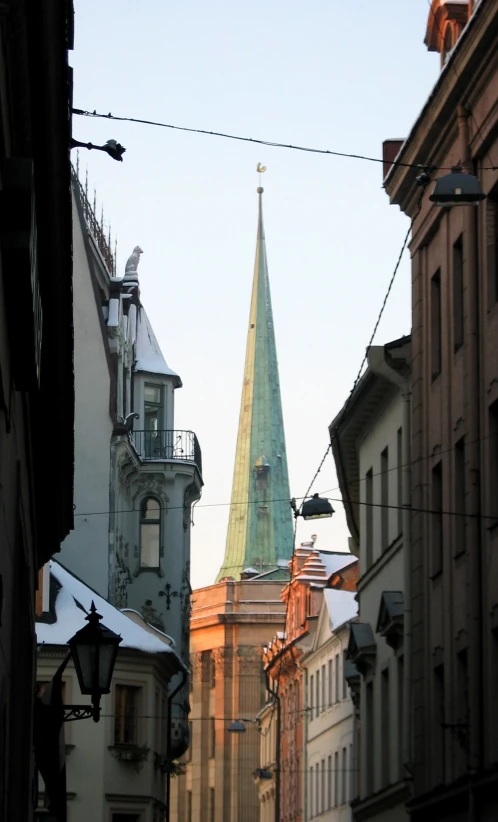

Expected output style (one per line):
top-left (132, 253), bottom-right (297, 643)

top-left (71, 0), bottom-right (439, 587)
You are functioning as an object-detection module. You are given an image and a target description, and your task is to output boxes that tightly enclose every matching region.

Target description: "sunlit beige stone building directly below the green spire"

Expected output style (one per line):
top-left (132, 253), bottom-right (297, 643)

top-left (171, 580), bottom-right (285, 822)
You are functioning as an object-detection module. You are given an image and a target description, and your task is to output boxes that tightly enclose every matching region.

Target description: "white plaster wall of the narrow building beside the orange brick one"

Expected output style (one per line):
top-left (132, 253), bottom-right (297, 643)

top-left (303, 628), bottom-right (354, 822)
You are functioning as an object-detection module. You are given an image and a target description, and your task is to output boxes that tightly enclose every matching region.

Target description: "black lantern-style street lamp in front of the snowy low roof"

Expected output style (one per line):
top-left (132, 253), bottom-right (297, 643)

top-left (65, 602), bottom-right (122, 722)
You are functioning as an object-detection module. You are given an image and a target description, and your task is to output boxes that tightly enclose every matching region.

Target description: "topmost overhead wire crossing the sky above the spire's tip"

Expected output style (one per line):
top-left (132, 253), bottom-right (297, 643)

top-left (72, 108), bottom-right (498, 171)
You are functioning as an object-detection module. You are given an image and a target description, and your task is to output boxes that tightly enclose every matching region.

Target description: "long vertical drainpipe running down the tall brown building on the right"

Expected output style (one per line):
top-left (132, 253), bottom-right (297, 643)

top-left (457, 106), bottom-right (483, 822)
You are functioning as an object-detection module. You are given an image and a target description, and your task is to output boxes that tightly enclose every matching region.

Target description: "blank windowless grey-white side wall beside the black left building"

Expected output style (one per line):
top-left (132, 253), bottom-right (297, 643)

top-left (59, 196), bottom-right (112, 598)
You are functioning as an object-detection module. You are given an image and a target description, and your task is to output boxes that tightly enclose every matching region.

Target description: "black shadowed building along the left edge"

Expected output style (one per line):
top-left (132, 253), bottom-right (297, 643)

top-left (0, 0), bottom-right (74, 820)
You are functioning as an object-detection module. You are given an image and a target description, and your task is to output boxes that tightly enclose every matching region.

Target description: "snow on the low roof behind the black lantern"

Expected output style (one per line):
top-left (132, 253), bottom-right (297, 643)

top-left (35, 560), bottom-right (184, 668)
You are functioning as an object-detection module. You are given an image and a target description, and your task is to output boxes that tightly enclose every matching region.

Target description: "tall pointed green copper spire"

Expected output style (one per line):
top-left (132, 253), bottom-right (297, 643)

top-left (218, 187), bottom-right (294, 580)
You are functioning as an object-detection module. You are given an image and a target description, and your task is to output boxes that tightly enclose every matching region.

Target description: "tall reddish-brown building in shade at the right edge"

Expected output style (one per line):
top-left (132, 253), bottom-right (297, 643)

top-left (385, 0), bottom-right (498, 822)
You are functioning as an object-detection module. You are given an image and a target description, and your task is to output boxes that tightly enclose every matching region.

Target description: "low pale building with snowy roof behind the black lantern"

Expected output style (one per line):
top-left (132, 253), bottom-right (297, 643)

top-left (36, 562), bottom-right (183, 822)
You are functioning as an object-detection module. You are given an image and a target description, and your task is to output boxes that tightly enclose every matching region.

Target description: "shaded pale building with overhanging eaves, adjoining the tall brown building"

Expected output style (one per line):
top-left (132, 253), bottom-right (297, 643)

top-left (330, 337), bottom-right (412, 822)
